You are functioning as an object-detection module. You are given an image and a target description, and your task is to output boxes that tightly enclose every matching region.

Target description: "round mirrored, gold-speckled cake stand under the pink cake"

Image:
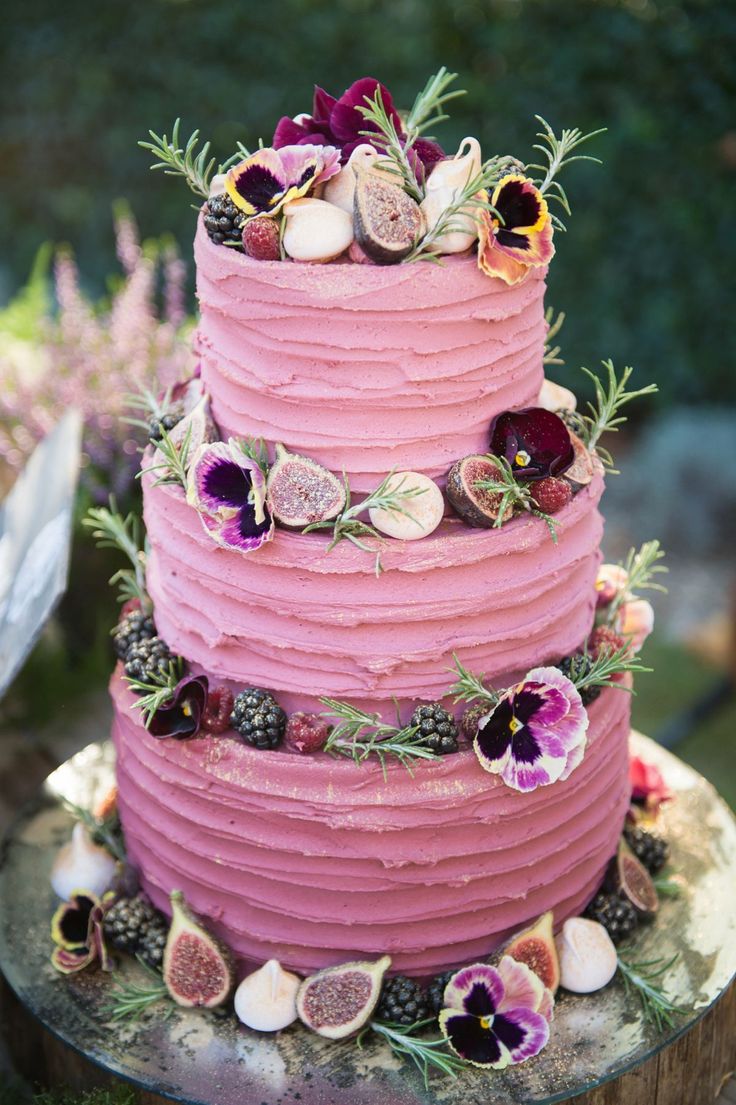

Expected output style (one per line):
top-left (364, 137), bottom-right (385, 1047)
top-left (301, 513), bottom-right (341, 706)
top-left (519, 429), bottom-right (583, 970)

top-left (0, 734), bottom-right (736, 1105)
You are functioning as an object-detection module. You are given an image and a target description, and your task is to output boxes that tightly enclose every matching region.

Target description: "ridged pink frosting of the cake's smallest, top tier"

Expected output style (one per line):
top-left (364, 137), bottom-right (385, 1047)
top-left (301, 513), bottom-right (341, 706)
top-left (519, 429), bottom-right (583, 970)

top-left (194, 220), bottom-right (547, 491)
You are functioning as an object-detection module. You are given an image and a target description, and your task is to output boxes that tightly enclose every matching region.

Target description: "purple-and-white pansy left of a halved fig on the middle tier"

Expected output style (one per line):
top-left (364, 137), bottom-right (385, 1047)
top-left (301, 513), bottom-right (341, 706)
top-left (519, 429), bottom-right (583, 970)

top-left (187, 438), bottom-right (274, 554)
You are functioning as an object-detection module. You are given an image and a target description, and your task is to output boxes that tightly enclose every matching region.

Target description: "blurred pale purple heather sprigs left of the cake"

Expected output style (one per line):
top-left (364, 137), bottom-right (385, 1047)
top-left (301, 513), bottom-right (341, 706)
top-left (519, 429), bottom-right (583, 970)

top-left (0, 206), bottom-right (192, 502)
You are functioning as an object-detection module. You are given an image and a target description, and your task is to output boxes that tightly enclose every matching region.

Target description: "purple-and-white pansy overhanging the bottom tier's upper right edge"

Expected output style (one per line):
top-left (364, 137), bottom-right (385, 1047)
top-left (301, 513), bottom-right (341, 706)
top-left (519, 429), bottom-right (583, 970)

top-left (473, 667), bottom-right (588, 793)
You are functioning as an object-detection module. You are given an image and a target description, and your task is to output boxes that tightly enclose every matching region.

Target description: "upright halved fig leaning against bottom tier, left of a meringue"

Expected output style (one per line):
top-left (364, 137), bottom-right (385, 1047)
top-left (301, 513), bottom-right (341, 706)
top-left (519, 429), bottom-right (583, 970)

top-left (164, 891), bottom-right (234, 1009)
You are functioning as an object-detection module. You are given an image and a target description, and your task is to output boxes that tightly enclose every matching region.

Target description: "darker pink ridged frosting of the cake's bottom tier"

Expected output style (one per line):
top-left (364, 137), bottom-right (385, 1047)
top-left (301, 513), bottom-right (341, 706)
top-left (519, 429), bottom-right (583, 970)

top-left (112, 674), bottom-right (630, 976)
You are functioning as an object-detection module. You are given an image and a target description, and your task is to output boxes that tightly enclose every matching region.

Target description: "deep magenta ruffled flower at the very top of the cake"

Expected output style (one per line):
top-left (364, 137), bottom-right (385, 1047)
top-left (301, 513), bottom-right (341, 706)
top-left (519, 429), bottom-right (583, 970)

top-left (273, 76), bottom-right (445, 175)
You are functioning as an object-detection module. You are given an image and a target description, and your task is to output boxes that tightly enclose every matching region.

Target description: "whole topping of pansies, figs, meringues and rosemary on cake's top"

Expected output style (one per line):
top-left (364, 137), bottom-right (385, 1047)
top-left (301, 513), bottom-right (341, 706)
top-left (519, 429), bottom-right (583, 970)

top-left (139, 67), bottom-right (601, 284)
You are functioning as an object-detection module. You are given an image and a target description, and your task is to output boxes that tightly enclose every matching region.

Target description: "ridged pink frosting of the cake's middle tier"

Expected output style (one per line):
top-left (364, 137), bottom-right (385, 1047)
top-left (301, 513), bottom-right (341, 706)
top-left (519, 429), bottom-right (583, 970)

top-left (144, 475), bottom-right (602, 716)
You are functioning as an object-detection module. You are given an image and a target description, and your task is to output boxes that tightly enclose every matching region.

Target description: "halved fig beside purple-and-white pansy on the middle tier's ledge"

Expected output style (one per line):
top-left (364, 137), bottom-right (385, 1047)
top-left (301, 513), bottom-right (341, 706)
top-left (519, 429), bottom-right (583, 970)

top-left (266, 445), bottom-right (345, 529)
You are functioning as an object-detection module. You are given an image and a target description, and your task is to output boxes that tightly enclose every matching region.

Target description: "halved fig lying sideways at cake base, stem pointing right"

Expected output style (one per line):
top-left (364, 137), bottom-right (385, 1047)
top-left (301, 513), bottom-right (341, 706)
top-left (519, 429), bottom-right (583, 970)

top-left (296, 956), bottom-right (391, 1040)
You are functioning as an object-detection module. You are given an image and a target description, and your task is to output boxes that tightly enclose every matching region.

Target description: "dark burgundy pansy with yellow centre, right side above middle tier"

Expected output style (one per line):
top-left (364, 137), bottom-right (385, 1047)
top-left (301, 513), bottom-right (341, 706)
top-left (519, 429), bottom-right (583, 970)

top-left (491, 407), bottom-right (575, 481)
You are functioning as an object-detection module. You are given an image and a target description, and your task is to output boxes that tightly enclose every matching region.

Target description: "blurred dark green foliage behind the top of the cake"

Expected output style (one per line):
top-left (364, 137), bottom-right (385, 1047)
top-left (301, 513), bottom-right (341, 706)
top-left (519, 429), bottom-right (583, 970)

top-left (0, 0), bottom-right (736, 402)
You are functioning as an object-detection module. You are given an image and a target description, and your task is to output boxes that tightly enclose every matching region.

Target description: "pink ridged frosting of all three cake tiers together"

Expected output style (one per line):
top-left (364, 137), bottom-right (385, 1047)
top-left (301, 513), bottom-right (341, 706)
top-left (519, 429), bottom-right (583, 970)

top-left (113, 225), bottom-right (629, 975)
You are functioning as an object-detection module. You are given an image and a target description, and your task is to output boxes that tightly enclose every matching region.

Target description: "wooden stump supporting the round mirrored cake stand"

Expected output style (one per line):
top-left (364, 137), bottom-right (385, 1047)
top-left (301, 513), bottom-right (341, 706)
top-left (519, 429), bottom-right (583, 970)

top-left (1, 979), bottom-right (736, 1105)
